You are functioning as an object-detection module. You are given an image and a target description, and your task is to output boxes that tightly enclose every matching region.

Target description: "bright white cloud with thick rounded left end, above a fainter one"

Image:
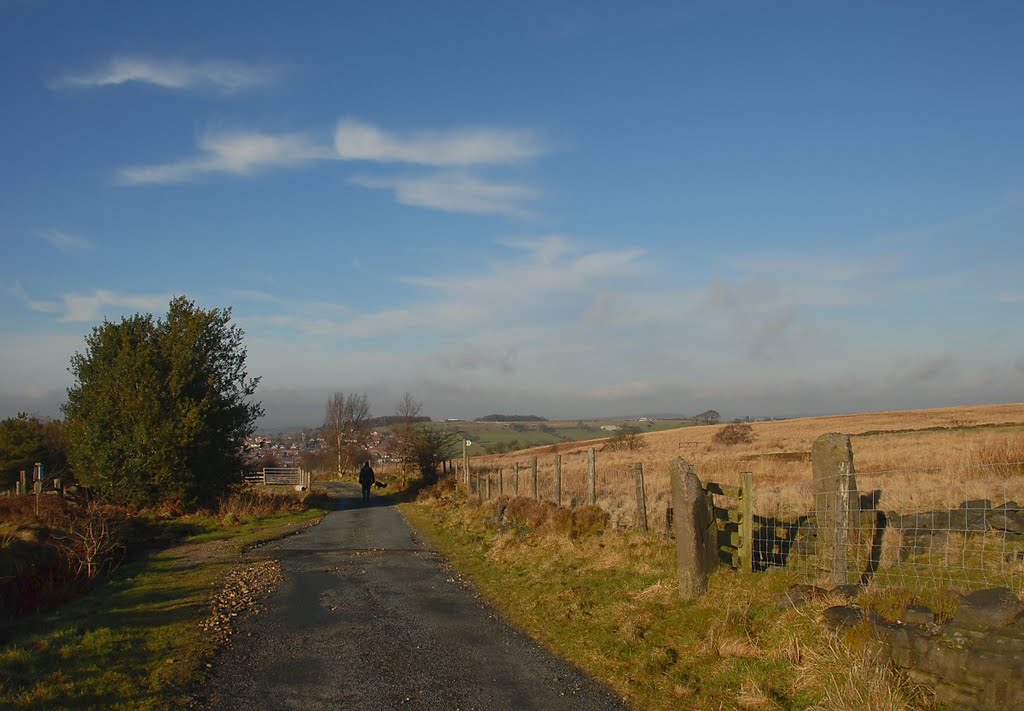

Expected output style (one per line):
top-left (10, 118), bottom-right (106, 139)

top-left (334, 118), bottom-right (545, 167)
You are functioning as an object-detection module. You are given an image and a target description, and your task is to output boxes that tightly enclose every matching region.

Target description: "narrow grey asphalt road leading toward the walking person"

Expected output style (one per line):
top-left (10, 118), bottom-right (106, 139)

top-left (202, 485), bottom-right (627, 711)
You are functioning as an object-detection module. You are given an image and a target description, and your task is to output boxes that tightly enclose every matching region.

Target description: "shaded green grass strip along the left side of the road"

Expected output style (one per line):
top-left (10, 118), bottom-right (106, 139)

top-left (0, 510), bottom-right (324, 709)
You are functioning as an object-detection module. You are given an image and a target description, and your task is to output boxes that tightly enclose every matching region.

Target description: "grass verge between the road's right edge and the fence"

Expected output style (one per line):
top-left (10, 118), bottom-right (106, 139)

top-left (402, 494), bottom-right (927, 710)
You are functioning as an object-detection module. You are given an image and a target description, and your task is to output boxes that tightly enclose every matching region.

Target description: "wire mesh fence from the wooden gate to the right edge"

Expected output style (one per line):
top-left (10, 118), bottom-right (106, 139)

top-left (754, 462), bottom-right (1024, 593)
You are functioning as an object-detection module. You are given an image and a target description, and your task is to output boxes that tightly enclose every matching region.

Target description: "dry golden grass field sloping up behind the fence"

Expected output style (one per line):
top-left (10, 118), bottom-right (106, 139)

top-left (471, 403), bottom-right (1024, 529)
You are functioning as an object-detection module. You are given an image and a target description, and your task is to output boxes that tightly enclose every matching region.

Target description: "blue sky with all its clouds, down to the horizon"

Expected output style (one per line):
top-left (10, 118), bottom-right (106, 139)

top-left (0, 0), bottom-right (1024, 428)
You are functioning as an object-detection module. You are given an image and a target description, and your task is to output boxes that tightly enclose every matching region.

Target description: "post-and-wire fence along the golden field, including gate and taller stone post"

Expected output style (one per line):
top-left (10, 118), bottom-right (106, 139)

top-left (457, 434), bottom-right (1024, 593)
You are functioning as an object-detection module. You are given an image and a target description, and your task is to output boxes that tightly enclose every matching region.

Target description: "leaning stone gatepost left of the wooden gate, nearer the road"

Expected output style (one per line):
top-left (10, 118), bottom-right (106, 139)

top-left (672, 458), bottom-right (718, 600)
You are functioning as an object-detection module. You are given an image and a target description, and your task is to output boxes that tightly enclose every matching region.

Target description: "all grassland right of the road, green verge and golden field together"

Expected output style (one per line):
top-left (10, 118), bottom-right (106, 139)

top-left (410, 404), bottom-right (1024, 711)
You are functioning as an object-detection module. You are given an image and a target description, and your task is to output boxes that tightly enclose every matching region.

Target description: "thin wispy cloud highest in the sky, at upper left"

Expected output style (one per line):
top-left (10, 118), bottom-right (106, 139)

top-left (50, 57), bottom-right (278, 92)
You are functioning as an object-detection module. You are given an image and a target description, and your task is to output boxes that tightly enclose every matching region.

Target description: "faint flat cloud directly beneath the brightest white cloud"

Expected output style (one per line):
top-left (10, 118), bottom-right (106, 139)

top-left (351, 172), bottom-right (542, 217)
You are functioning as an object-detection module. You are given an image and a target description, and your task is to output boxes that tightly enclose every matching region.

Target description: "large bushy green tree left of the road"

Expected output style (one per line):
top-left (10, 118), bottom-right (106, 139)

top-left (63, 296), bottom-right (263, 507)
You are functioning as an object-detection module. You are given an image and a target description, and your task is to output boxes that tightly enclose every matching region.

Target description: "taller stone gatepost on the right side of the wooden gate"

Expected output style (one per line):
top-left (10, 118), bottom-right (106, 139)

top-left (811, 432), bottom-right (860, 585)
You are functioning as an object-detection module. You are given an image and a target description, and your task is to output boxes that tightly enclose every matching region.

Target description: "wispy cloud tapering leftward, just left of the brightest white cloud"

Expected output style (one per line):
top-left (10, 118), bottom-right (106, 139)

top-left (117, 131), bottom-right (336, 185)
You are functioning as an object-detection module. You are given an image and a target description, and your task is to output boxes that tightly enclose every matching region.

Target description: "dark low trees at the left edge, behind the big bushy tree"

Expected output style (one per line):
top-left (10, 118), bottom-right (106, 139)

top-left (0, 412), bottom-right (69, 490)
